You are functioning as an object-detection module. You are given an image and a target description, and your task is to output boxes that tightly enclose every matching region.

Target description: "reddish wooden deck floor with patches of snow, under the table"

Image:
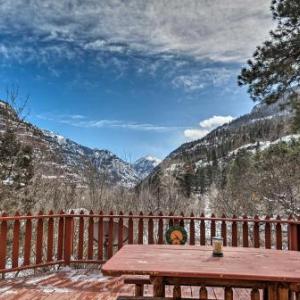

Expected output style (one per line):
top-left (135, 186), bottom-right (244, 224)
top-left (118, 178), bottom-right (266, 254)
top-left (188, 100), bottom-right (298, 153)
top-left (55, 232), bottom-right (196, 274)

top-left (0, 269), bottom-right (250, 300)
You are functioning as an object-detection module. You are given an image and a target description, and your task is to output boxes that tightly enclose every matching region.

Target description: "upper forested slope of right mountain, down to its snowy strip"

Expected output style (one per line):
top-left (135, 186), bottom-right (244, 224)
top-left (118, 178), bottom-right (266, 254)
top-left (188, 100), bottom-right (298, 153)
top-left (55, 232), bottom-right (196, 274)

top-left (139, 95), bottom-right (298, 193)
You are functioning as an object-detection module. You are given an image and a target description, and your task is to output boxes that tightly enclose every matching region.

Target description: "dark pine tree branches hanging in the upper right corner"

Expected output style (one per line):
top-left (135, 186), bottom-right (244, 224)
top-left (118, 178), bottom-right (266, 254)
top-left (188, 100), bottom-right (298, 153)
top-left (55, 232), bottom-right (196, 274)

top-left (238, 0), bottom-right (300, 103)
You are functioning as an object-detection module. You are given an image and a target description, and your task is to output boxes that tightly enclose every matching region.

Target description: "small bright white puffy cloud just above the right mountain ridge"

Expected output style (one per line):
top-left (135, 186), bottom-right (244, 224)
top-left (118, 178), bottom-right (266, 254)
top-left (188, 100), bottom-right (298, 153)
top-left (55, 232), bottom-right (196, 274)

top-left (183, 116), bottom-right (234, 141)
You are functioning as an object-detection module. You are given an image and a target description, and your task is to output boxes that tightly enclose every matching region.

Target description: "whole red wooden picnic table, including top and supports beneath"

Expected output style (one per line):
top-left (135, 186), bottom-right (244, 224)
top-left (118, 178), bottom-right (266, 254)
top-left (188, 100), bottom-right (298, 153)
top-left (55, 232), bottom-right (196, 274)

top-left (102, 245), bottom-right (300, 300)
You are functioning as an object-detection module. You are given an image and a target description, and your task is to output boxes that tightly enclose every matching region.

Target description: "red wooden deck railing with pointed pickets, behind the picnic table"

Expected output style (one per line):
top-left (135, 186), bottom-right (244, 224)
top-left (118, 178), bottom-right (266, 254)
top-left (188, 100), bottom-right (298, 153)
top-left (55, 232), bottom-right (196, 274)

top-left (0, 211), bottom-right (300, 273)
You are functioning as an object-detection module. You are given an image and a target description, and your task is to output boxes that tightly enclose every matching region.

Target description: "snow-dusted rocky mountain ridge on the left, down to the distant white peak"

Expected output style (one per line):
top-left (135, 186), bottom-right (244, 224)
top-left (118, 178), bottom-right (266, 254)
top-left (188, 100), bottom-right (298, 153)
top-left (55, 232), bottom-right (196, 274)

top-left (0, 101), bottom-right (158, 187)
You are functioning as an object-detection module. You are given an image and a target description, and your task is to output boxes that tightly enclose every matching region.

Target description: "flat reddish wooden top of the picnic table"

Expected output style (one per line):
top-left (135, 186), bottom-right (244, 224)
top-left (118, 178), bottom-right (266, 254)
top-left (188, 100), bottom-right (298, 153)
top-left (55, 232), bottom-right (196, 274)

top-left (102, 245), bottom-right (300, 283)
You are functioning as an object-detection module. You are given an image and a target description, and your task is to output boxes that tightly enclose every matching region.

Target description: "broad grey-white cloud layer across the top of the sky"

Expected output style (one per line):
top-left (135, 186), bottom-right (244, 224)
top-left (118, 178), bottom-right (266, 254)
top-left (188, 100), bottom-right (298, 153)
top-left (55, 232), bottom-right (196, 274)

top-left (0, 0), bottom-right (272, 62)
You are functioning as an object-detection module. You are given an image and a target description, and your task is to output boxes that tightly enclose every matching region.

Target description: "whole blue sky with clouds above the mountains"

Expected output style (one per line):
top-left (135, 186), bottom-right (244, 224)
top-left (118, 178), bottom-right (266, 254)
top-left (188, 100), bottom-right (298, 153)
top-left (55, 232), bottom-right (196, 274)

top-left (0, 0), bottom-right (272, 161)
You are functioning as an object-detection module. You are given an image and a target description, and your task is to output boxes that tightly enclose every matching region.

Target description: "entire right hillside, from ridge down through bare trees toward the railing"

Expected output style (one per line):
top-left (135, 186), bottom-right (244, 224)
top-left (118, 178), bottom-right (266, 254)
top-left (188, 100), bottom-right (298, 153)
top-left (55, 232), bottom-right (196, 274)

top-left (136, 99), bottom-right (299, 213)
